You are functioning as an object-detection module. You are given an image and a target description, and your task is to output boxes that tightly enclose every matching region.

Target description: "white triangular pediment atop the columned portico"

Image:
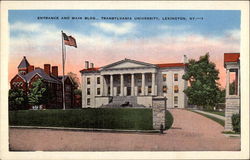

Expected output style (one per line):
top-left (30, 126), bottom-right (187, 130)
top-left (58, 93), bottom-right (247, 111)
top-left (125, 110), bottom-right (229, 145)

top-left (102, 59), bottom-right (155, 69)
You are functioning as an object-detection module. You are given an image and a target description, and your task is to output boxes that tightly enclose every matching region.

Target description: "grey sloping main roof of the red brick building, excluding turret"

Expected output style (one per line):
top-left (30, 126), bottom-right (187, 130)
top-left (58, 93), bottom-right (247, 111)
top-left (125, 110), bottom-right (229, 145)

top-left (24, 68), bottom-right (60, 83)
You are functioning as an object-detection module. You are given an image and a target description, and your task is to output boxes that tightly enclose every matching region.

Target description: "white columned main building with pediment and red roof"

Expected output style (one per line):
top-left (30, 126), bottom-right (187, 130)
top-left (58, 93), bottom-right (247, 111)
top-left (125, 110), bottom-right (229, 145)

top-left (80, 59), bottom-right (187, 108)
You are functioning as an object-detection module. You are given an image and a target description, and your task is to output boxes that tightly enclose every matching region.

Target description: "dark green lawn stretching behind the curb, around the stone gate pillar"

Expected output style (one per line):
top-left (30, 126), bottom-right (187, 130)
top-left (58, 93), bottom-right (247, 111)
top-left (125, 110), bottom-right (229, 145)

top-left (9, 108), bottom-right (173, 130)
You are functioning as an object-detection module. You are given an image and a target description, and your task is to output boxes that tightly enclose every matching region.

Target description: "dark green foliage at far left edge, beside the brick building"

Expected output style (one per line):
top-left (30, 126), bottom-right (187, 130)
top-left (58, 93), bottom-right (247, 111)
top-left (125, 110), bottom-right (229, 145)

top-left (9, 89), bottom-right (27, 110)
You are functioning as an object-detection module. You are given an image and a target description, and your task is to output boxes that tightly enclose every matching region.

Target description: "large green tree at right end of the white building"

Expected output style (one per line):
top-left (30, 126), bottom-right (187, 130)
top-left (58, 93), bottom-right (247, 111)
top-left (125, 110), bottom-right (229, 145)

top-left (182, 53), bottom-right (220, 109)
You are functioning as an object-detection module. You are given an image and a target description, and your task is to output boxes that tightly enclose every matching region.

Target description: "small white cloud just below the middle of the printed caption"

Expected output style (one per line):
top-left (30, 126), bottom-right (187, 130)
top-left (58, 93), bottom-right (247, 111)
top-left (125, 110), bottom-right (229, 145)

top-left (92, 22), bottom-right (136, 35)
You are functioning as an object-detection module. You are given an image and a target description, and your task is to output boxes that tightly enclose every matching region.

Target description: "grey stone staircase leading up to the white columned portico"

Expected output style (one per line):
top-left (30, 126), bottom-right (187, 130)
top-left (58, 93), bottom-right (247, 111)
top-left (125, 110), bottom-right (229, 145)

top-left (102, 96), bottom-right (145, 108)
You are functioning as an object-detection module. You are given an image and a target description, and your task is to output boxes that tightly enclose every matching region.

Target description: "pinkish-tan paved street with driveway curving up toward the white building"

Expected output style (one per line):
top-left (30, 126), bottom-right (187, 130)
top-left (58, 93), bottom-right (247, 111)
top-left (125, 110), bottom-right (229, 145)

top-left (10, 109), bottom-right (240, 151)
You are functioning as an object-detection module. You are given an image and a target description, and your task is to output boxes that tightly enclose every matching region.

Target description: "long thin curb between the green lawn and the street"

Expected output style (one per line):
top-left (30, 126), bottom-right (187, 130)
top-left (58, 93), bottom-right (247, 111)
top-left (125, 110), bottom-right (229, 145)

top-left (9, 126), bottom-right (160, 133)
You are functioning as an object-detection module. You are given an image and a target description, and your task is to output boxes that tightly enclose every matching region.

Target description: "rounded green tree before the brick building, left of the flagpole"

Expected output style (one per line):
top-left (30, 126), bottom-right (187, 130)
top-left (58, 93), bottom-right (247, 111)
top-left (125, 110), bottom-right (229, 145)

top-left (28, 79), bottom-right (49, 105)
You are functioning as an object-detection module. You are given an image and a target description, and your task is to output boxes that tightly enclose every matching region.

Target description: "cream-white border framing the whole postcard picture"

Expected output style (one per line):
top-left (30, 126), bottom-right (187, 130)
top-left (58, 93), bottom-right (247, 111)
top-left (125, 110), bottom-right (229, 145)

top-left (0, 1), bottom-right (249, 160)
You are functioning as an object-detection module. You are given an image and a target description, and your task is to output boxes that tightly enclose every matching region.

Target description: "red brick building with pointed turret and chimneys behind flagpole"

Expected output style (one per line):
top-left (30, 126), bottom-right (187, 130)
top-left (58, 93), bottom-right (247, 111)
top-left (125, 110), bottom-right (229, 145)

top-left (10, 56), bottom-right (75, 108)
